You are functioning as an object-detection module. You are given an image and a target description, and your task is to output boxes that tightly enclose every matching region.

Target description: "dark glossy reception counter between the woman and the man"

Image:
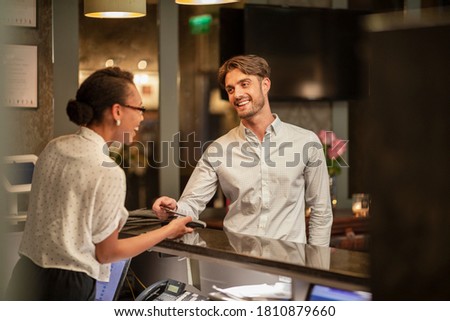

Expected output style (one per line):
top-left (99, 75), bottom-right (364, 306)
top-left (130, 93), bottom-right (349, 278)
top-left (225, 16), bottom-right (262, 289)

top-left (122, 209), bottom-right (370, 300)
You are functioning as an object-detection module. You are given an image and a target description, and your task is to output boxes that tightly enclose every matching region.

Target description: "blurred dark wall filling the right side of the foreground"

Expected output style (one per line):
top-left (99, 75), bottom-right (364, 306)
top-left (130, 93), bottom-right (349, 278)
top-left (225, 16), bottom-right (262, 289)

top-left (359, 11), bottom-right (450, 300)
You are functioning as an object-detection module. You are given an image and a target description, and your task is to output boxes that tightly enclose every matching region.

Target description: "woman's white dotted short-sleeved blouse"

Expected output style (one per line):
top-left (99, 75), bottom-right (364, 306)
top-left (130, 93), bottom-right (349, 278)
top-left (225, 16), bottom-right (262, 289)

top-left (19, 127), bottom-right (128, 281)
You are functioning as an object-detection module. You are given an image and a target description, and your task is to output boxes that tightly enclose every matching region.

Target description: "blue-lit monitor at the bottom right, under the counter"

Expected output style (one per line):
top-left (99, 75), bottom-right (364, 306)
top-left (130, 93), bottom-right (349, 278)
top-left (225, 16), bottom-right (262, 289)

top-left (306, 284), bottom-right (372, 301)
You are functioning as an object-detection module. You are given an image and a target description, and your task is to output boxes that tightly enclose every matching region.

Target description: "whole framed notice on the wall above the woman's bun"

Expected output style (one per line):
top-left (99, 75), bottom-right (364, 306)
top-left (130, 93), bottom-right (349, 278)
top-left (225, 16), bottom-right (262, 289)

top-left (3, 45), bottom-right (38, 108)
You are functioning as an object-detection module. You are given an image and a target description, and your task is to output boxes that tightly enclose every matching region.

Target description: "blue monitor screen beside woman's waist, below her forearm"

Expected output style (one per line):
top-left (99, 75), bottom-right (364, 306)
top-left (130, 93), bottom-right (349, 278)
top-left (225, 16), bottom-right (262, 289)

top-left (95, 259), bottom-right (131, 301)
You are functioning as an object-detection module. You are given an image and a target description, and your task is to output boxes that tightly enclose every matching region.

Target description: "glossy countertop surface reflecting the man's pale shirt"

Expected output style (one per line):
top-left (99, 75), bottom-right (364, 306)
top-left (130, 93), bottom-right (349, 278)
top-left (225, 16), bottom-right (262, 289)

top-left (172, 229), bottom-right (369, 279)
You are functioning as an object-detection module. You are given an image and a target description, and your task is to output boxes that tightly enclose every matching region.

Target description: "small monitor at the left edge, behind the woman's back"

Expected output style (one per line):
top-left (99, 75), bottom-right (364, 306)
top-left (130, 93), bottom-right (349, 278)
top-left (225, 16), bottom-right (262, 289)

top-left (3, 154), bottom-right (38, 193)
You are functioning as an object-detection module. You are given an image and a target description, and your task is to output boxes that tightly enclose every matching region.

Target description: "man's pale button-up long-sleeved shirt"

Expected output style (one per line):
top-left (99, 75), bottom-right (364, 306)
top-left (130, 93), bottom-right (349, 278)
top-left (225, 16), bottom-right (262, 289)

top-left (178, 115), bottom-right (333, 246)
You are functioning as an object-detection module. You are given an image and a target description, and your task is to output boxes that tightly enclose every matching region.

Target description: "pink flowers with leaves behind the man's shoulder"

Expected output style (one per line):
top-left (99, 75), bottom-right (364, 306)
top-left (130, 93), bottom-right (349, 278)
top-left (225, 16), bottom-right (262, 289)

top-left (319, 130), bottom-right (348, 177)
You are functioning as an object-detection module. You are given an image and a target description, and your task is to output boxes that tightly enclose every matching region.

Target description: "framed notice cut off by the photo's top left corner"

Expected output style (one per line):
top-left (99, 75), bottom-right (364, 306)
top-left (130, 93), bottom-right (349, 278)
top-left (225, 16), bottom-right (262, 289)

top-left (3, 0), bottom-right (36, 28)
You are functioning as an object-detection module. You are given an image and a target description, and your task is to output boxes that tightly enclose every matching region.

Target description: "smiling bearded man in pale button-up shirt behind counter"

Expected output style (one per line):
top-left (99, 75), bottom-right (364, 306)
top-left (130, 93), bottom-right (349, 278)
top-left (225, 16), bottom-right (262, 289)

top-left (153, 55), bottom-right (333, 246)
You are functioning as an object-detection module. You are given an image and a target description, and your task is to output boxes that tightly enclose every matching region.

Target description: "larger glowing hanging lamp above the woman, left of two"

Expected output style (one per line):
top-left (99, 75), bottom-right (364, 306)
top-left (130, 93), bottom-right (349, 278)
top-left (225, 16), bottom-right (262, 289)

top-left (84, 0), bottom-right (147, 18)
